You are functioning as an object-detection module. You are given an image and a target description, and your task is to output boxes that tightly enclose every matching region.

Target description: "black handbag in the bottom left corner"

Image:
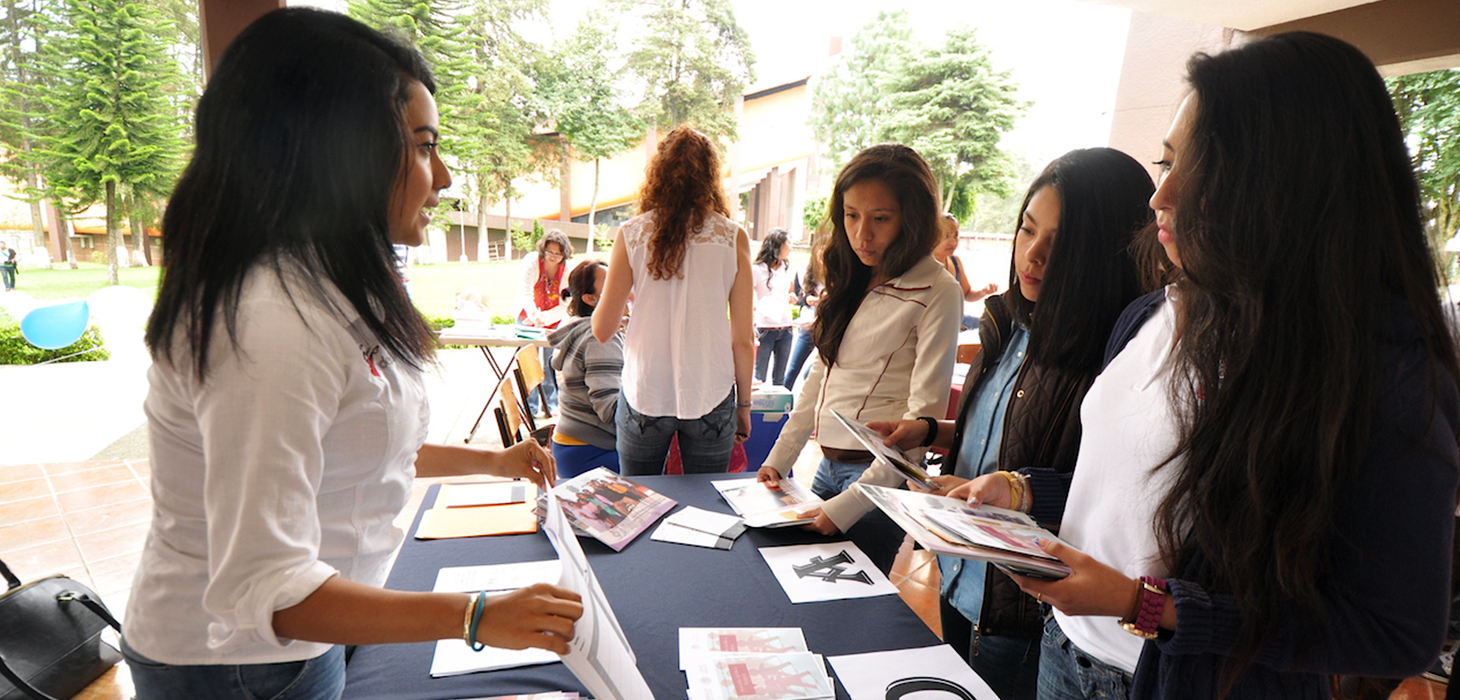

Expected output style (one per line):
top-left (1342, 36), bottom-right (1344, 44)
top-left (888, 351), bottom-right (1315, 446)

top-left (0, 561), bottom-right (121, 700)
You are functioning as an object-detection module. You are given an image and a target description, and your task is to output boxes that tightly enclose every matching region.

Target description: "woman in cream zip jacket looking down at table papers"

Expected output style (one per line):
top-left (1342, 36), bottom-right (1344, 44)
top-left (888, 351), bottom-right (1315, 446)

top-left (758, 143), bottom-right (964, 570)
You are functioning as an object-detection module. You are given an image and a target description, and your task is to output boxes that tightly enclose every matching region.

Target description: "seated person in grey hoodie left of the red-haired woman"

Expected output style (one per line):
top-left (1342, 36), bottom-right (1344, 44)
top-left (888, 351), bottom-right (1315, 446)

top-left (548, 260), bottom-right (623, 479)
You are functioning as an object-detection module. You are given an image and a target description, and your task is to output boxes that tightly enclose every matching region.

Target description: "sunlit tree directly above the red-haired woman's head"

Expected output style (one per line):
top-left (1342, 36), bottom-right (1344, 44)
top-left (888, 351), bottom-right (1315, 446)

top-left (615, 0), bottom-right (755, 143)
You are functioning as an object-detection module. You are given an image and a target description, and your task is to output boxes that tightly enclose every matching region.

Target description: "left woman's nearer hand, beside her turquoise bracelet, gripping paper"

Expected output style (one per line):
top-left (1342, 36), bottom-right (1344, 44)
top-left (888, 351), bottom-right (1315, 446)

top-left (476, 583), bottom-right (583, 655)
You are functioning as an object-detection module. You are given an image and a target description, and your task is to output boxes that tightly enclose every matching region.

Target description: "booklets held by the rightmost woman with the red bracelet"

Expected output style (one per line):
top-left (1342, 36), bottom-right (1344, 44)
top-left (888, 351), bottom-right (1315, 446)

top-left (856, 484), bottom-right (1072, 579)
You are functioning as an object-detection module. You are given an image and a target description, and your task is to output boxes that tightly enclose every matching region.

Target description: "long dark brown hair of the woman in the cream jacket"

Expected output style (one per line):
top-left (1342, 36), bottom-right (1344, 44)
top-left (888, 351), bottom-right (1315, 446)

top-left (812, 143), bottom-right (943, 365)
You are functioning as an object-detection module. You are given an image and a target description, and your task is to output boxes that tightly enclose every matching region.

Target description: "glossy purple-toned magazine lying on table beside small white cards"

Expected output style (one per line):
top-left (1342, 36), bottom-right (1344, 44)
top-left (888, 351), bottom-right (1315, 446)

top-left (553, 466), bottom-right (677, 551)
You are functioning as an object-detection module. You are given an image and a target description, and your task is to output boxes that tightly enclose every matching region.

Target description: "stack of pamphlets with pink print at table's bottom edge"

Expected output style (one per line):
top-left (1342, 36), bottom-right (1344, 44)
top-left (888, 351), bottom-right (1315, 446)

top-left (679, 627), bottom-right (835, 700)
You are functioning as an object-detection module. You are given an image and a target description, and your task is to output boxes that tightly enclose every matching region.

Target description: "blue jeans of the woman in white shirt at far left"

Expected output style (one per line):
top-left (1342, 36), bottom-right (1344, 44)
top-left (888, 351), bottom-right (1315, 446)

top-left (121, 639), bottom-right (345, 700)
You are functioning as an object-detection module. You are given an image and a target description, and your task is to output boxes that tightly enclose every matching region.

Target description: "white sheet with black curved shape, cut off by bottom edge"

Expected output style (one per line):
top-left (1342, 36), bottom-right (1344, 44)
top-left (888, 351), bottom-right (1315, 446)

top-left (828, 644), bottom-right (999, 700)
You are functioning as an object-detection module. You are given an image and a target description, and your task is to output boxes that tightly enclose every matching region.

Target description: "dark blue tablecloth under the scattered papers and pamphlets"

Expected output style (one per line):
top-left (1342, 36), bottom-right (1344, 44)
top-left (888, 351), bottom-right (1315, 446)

top-left (345, 473), bottom-right (939, 700)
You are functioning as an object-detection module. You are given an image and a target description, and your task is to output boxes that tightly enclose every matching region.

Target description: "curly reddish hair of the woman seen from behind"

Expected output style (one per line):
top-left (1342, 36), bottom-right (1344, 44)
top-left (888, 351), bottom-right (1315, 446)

top-left (638, 126), bottom-right (730, 279)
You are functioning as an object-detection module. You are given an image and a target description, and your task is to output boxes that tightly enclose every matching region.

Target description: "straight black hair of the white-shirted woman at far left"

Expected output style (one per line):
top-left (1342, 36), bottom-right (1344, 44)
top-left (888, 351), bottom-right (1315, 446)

top-left (147, 7), bottom-right (435, 380)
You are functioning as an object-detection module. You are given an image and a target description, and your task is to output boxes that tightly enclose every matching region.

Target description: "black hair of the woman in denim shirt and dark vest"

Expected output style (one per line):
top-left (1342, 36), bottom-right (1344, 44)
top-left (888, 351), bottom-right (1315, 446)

top-left (1004, 148), bottom-right (1155, 371)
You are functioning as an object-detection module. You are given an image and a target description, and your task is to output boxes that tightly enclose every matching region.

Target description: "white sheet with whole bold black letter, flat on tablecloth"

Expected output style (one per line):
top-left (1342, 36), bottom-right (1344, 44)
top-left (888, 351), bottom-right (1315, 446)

top-left (761, 542), bottom-right (898, 604)
